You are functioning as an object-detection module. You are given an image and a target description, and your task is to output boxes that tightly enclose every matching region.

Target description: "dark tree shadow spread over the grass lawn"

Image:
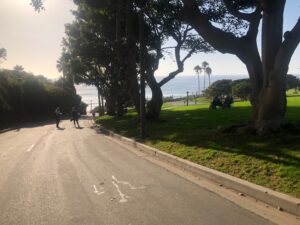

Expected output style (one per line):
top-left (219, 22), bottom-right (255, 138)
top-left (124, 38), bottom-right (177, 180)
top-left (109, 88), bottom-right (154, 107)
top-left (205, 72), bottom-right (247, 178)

top-left (149, 107), bottom-right (300, 167)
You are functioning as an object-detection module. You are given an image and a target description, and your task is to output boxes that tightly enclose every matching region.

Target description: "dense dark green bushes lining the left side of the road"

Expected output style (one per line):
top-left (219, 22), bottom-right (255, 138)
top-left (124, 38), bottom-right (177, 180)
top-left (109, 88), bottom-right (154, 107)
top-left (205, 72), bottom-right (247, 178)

top-left (0, 70), bottom-right (86, 126)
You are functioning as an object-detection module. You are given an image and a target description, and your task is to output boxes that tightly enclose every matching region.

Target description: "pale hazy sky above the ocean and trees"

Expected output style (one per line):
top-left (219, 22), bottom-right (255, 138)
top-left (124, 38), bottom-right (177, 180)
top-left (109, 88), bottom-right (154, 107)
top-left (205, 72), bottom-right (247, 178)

top-left (0, 0), bottom-right (300, 79)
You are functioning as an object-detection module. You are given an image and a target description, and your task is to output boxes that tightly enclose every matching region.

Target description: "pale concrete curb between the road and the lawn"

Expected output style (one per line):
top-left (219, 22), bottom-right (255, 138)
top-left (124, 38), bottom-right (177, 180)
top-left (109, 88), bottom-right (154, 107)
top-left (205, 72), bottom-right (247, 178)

top-left (99, 126), bottom-right (300, 216)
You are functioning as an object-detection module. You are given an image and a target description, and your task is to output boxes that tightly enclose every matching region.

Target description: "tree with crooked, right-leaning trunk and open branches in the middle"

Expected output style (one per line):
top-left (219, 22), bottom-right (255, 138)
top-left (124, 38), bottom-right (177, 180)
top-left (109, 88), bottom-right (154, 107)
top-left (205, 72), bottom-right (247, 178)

top-left (143, 1), bottom-right (213, 120)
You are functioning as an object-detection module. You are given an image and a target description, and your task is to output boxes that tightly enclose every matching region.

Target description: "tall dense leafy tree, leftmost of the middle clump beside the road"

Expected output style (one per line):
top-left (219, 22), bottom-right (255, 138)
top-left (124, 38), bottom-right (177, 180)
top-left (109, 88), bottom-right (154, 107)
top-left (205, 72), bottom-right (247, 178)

top-left (58, 0), bottom-right (134, 115)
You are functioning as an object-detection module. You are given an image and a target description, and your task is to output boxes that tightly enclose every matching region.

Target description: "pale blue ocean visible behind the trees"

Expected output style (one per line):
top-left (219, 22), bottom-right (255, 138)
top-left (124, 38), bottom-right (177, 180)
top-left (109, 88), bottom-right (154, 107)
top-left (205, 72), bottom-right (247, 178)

top-left (75, 75), bottom-right (299, 106)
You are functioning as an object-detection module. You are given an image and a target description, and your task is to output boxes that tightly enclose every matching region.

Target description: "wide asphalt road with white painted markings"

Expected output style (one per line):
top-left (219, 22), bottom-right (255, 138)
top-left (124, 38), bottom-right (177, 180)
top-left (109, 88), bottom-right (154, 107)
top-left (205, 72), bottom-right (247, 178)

top-left (0, 120), bottom-right (272, 225)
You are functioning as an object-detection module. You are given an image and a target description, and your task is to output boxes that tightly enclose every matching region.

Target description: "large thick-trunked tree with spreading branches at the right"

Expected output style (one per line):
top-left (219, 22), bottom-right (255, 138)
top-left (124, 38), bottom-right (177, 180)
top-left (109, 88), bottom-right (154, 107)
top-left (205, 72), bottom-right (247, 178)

top-left (180, 0), bottom-right (300, 134)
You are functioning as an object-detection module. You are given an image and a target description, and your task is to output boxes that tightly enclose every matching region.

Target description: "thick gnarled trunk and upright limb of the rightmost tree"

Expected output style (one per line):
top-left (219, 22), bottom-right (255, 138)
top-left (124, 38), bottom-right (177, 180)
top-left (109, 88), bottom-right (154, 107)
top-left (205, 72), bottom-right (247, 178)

top-left (255, 0), bottom-right (288, 134)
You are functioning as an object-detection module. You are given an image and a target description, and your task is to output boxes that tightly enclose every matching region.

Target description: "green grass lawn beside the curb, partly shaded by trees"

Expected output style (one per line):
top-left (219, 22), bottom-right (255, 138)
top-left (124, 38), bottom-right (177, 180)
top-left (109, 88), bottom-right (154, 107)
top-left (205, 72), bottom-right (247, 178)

top-left (97, 95), bottom-right (300, 197)
